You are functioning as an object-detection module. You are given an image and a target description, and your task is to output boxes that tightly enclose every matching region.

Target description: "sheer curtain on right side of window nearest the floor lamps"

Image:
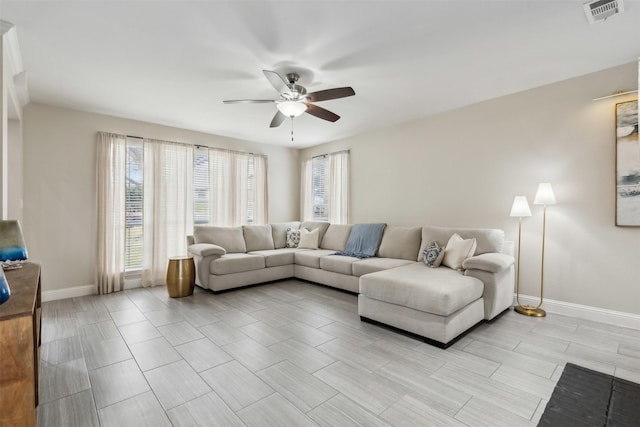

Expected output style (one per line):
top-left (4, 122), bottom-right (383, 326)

top-left (329, 151), bottom-right (349, 224)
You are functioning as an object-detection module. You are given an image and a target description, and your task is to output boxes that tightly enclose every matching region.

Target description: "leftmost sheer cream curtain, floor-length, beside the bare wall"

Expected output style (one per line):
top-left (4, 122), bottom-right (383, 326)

top-left (96, 132), bottom-right (127, 294)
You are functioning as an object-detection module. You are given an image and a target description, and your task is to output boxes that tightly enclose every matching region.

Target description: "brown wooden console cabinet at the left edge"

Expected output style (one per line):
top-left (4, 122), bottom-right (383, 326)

top-left (0, 263), bottom-right (42, 427)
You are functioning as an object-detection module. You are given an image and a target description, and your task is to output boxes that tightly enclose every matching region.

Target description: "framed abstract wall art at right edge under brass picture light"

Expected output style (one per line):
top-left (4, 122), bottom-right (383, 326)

top-left (616, 100), bottom-right (640, 227)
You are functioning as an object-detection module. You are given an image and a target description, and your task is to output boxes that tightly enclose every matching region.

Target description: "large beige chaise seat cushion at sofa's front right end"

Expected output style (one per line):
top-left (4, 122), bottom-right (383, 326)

top-left (360, 263), bottom-right (484, 316)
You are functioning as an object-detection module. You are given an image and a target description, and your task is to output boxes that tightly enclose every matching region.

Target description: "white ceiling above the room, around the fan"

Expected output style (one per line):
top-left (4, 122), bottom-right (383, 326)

top-left (0, 0), bottom-right (640, 147)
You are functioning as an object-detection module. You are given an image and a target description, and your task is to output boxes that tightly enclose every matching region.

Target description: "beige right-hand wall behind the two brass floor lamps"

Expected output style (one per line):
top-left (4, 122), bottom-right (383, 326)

top-left (301, 63), bottom-right (640, 314)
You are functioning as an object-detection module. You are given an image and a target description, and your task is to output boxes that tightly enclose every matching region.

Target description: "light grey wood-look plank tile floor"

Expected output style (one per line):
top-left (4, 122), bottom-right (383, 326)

top-left (39, 280), bottom-right (640, 427)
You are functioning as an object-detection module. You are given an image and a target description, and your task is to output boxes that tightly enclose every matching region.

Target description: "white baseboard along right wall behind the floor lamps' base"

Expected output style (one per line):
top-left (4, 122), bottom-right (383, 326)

top-left (513, 295), bottom-right (640, 329)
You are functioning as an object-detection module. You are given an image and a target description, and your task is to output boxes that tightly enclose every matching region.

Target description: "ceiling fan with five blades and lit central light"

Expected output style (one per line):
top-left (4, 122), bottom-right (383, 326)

top-left (222, 70), bottom-right (356, 128)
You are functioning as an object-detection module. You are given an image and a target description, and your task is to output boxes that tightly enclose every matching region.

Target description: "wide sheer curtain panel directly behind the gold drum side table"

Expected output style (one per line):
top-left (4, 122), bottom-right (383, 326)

top-left (142, 139), bottom-right (193, 286)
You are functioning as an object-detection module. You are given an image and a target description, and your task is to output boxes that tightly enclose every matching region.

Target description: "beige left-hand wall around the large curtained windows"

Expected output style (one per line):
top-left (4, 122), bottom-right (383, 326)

top-left (23, 104), bottom-right (300, 291)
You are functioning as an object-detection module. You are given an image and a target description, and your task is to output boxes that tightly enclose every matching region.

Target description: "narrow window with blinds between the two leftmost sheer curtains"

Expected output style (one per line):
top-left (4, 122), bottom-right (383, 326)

top-left (124, 138), bottom-right (144, 271)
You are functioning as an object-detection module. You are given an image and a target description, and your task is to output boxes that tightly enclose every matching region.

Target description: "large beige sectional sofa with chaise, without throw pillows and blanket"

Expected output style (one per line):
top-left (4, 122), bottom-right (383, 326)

top-left (187, 222), bottom-right (514, 347)
